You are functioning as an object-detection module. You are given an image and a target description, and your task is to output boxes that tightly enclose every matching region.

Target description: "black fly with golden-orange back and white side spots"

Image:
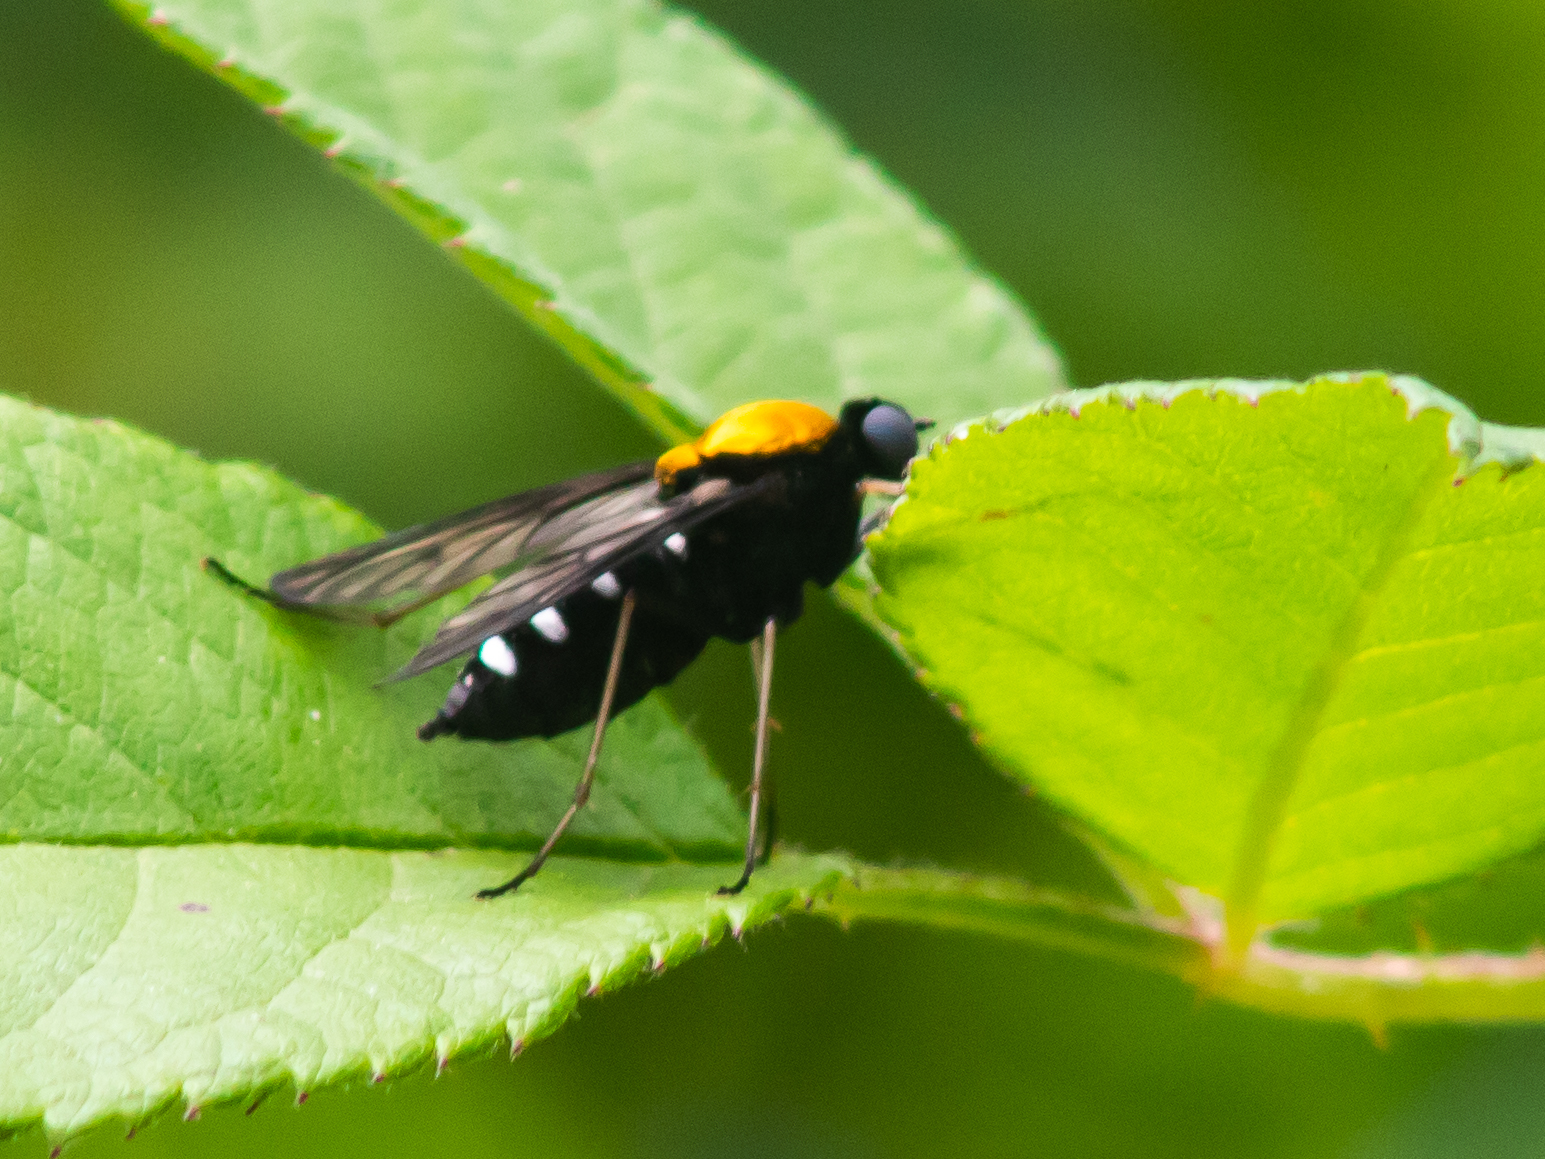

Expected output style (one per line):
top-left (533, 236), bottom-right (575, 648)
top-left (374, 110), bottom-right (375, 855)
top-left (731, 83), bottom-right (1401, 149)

top-left (205, 399), bottom-right (929, 898)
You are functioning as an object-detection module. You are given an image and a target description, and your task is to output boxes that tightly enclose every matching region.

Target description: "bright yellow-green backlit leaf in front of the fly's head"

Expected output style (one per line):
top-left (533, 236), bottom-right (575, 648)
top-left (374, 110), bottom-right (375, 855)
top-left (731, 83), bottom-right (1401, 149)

top-left (871, 376), bottom-right (1545, 950)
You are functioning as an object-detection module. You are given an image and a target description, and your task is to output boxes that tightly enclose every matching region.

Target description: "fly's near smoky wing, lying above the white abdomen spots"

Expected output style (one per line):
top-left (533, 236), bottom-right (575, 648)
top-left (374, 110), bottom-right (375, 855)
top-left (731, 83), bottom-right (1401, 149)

top-left (391, 474), bottom-right (783, 680)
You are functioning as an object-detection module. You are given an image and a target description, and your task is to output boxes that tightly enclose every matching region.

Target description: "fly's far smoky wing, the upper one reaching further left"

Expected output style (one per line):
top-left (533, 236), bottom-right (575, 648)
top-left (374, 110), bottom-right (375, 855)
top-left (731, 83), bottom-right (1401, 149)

top-left (269, 461), bottom-right (654, 611)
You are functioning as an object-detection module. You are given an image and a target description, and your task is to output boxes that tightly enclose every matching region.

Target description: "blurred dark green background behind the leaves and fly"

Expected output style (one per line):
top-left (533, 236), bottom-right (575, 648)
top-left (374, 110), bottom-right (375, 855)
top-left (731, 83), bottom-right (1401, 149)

top-left (0, 0), bottom-right (1545, 1159)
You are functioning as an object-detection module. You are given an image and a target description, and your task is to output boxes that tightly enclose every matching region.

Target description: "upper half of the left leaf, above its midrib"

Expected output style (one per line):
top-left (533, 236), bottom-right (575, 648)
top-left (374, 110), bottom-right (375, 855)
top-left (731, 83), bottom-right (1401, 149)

top-left (0, 397), bottom-right (745, 858)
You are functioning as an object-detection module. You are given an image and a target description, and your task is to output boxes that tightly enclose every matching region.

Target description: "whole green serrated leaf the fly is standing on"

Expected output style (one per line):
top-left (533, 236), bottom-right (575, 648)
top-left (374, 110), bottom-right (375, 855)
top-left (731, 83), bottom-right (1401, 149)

top-left (0, 397), bottom-right (844, 1136)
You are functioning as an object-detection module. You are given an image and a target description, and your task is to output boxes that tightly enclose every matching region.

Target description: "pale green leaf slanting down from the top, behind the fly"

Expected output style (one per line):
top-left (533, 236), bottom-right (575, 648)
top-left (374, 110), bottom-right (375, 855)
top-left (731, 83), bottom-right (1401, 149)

top-left (122, 0), bottom-right (1061, 437)
